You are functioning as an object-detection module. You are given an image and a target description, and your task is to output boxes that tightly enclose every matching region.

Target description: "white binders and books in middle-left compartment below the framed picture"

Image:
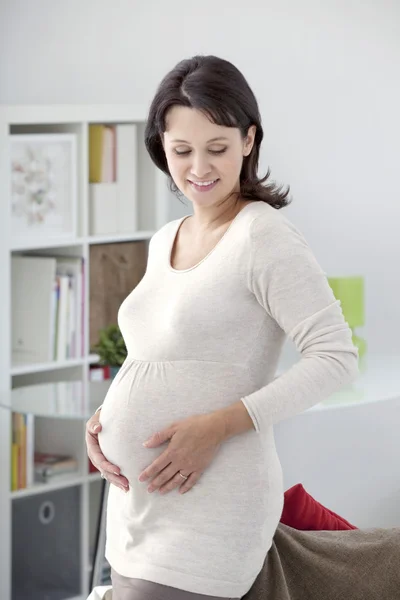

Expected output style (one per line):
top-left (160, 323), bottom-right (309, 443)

top-left (11, 256), bottom-right (84, 365)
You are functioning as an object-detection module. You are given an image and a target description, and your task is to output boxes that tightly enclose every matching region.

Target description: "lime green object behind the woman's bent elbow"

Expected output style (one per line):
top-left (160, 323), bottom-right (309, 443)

top-left (328, 276), bottom-right (367, 358)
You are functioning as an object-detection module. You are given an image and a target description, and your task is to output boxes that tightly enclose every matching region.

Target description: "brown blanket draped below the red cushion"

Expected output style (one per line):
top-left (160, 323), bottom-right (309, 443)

top-left (243, 523), bottom-right (400, 600)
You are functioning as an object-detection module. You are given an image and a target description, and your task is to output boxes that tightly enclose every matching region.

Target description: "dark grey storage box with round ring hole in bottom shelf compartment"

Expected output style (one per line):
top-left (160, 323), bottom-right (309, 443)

top-left (12, 486), bottom-right (81, 600)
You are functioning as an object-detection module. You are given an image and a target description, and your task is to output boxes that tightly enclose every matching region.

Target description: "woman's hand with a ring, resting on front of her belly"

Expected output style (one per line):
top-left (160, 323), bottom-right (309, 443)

top-left (139, 413), bottom-right (224, 494)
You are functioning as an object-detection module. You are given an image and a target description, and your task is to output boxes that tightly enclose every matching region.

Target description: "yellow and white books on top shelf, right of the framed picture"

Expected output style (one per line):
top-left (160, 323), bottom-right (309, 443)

top-left (89, 123), bottom-right (138, 235)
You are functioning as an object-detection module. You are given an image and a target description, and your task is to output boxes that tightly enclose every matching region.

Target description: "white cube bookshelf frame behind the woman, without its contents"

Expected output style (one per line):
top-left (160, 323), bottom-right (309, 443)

top-left (0, 104), bottom-right (188, 600)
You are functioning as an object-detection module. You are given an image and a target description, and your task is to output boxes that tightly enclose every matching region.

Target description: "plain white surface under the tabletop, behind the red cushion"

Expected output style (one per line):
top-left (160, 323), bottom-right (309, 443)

top-left (275, 397), bottom-right (400, 528)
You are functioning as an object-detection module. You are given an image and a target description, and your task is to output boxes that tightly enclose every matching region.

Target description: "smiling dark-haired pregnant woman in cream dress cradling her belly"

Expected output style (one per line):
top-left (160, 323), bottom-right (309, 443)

top-left (86, 56), bottom-right (358, 600)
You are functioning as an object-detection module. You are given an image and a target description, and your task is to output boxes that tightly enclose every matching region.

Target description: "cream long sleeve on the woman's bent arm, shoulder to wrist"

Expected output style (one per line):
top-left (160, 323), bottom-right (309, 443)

top-left (241, 215), bottom-right (358, 433)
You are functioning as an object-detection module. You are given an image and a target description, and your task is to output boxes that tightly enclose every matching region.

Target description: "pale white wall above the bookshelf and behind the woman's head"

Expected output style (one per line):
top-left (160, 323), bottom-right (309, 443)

top-left (0, 0), bottom-right (400, 352)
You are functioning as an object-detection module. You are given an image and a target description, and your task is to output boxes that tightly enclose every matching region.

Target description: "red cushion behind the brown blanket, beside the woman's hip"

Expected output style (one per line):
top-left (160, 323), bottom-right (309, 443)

top-left (281, 483), bottom-right (357, 531)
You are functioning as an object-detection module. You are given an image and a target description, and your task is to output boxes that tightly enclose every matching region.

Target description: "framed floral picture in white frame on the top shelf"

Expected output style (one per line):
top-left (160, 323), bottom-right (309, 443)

top-left (10, 133), bottom-right (78, 245)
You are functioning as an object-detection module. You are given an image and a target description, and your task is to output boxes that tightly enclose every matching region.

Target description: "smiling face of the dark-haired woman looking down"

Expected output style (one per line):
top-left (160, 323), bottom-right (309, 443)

top-left (163, 106), bottom-right (255, 206)
